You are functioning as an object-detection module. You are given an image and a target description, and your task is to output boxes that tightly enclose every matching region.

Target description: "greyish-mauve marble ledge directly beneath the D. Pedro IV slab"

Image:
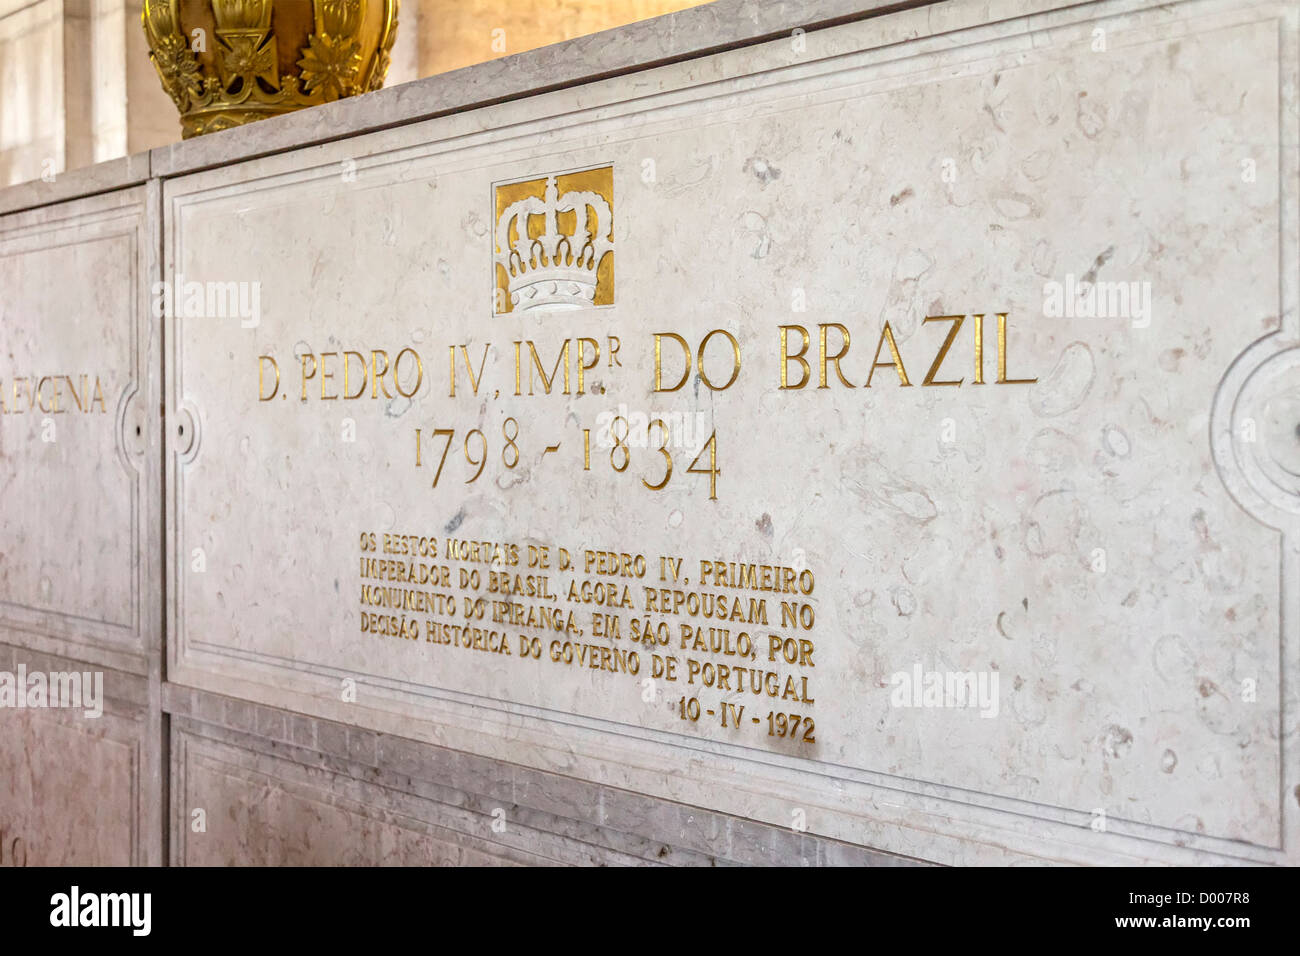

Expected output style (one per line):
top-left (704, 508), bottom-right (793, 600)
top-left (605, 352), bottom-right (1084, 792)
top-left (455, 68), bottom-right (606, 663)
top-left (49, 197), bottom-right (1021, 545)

top-left (163, 683), bottom-right (926, 866)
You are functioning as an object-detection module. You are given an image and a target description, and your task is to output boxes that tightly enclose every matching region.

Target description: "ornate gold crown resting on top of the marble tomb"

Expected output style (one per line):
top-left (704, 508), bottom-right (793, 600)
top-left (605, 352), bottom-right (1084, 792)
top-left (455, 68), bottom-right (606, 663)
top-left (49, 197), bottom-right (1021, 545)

top-left (140, 0), bottom-right (398, 139)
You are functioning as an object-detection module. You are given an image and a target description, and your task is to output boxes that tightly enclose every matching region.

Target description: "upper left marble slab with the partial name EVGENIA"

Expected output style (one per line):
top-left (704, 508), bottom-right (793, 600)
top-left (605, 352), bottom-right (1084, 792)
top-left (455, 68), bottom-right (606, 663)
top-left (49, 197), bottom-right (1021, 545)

top-left (0, 187), bottom-right (163, 674)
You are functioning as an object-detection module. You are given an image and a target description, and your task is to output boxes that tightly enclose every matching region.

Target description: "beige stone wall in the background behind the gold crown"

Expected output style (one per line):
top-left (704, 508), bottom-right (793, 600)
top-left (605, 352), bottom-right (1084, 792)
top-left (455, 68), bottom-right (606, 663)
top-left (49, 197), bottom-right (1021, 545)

top-left (0, 0), bottom-right (712, 185)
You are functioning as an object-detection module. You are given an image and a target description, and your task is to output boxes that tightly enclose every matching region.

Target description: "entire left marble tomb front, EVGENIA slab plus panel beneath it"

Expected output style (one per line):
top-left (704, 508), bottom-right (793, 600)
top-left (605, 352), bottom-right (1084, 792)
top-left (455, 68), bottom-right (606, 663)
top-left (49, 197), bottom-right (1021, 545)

top-left (0, 179), bottom-right (165, 865)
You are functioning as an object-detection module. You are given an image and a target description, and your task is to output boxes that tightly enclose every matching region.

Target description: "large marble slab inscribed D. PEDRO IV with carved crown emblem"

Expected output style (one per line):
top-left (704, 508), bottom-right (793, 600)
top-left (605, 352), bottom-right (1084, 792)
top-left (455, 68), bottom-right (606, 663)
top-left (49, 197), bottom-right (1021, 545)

top-left (164, 0), bottom-right (1300, 862)
